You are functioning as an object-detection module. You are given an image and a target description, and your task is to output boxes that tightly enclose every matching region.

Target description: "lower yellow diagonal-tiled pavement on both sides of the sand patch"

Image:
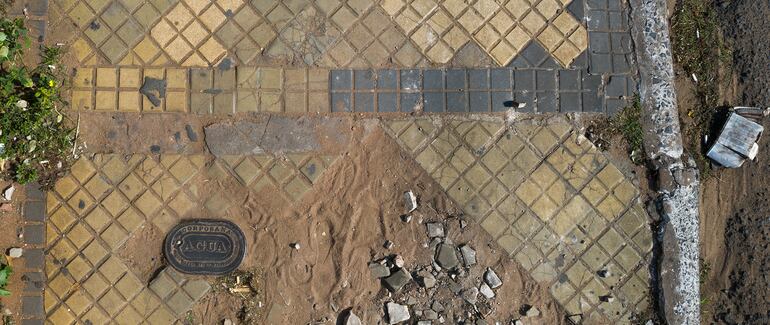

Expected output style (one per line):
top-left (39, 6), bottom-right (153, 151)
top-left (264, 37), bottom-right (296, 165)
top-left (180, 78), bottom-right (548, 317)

top-left (45, 118), bottom-right (651, 325)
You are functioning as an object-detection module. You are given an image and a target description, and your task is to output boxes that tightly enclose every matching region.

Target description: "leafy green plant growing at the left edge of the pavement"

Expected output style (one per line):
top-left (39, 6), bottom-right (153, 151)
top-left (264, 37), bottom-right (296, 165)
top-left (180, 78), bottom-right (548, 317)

top-left (0, 18), bottom-right (74, 184)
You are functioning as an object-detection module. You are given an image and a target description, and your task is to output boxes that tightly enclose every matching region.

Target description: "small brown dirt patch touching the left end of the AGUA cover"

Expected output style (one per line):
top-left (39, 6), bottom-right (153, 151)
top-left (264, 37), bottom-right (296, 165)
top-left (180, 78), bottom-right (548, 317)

top-left (118, 222), bottom-right (165, 283)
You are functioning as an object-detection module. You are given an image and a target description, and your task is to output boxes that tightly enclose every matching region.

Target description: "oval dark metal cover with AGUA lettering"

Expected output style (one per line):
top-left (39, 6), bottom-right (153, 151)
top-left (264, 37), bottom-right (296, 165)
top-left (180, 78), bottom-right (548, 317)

top-left (163, 220), bottom-right (246, 275)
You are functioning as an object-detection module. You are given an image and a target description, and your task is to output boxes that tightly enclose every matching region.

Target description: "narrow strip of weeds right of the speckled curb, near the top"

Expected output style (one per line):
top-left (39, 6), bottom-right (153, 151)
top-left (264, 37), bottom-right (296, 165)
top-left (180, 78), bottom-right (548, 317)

top-left (671, 0), bottom-right (732, 177)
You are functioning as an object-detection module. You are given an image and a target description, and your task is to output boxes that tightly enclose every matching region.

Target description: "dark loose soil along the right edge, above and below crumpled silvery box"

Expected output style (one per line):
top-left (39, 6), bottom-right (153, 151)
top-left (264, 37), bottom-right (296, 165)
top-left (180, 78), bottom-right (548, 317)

top-left (672, 0), bottom-right (770, 324)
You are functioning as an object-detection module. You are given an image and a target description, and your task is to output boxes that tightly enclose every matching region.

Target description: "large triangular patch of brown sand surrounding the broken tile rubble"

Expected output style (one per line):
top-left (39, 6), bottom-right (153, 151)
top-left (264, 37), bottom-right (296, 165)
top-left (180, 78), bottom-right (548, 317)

top-left (172, 123), bottom-right (563, 324)
